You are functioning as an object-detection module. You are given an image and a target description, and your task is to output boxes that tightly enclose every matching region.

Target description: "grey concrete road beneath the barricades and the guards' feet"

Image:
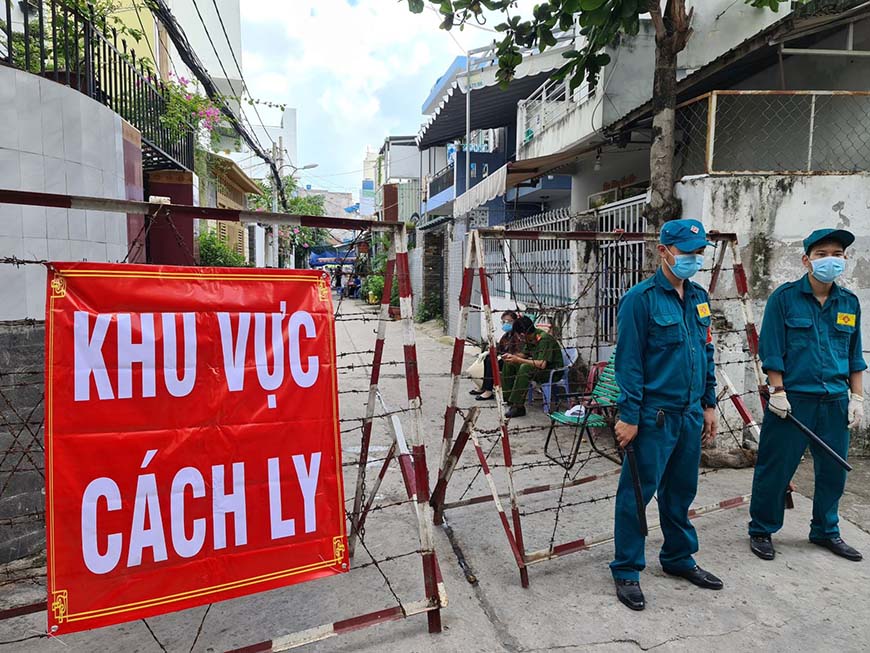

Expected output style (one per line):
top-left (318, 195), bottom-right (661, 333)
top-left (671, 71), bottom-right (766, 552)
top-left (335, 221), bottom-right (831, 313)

top-left (0, 302), bottom-right (870, 653)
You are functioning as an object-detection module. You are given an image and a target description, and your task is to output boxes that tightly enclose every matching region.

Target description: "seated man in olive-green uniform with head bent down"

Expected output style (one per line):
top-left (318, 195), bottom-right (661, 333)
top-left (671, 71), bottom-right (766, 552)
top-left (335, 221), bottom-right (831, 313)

top-left (502, 315), bottom-right (563, 418)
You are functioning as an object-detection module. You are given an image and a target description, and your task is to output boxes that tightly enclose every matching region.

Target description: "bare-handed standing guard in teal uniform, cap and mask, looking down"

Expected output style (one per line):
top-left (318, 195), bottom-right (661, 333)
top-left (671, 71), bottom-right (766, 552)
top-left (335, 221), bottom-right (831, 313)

top-left (610, 220), bottom-right (722, 610)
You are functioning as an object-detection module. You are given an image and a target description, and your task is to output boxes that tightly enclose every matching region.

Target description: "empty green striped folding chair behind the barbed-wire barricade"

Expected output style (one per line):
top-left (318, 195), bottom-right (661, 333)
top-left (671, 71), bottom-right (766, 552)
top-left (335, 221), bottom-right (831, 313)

top-left (544, 352), bottom-right (622, 469)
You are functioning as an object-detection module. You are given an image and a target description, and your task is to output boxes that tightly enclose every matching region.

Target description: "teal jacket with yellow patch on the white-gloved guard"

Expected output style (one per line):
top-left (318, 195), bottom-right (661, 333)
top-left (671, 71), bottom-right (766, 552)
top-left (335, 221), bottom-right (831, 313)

top-left (758, 275), bottom-right (867, 395)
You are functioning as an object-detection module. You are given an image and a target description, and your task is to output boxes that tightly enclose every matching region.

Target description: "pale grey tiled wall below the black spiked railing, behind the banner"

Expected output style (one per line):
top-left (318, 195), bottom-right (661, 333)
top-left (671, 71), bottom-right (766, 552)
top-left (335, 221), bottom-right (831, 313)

top-left (0, 67), bottom-right (127, 320)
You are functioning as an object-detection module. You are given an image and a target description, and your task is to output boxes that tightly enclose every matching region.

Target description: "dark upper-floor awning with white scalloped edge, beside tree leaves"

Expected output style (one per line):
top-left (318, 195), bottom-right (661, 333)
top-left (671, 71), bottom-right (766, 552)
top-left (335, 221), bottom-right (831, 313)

top-left (417, 45), bottom-right (573, 149)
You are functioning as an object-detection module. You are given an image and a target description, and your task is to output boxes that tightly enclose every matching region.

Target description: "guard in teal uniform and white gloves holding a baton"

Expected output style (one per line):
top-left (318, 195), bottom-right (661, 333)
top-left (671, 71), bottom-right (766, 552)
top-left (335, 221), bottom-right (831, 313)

top-left (749, 229), bottom-right (867, 561)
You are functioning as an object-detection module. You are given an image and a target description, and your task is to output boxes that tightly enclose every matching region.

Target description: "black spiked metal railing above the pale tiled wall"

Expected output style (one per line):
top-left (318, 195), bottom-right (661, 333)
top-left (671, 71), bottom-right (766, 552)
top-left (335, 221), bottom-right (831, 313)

top-left (0, 0), bottom-right (195, 170)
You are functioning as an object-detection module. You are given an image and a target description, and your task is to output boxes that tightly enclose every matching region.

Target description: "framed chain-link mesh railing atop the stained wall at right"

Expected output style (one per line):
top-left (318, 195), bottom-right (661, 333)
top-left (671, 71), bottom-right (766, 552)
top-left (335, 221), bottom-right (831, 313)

top-left (676, 91), bottom-right (870, 176)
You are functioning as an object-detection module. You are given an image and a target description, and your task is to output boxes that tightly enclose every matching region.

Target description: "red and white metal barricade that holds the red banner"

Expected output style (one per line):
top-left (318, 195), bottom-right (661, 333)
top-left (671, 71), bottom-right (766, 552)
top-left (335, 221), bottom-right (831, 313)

top-left (0, 189), bottom-right (447, 651)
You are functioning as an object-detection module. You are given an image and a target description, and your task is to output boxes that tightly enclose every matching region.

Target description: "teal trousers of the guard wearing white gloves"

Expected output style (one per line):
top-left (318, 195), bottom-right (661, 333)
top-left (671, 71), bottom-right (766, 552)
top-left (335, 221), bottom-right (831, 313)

top-left (749, 394), bottom-right (849, 540)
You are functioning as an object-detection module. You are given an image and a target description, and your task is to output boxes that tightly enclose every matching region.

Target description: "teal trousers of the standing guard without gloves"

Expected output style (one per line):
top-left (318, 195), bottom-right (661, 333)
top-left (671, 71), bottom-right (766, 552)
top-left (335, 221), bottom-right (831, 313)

top-left (610, 406), bottom-right (704, 580)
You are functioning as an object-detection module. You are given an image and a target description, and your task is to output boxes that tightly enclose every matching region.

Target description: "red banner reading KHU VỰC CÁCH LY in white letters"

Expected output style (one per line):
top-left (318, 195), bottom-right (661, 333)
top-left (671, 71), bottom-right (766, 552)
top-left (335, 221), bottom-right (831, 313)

top-left (45, 263), bottom-right (348, 634)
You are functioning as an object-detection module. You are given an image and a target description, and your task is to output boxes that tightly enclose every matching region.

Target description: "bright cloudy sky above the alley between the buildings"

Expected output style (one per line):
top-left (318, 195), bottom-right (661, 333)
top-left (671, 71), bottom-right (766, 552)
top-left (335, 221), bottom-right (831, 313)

top-left (240, 0), bottom-right (532, 197)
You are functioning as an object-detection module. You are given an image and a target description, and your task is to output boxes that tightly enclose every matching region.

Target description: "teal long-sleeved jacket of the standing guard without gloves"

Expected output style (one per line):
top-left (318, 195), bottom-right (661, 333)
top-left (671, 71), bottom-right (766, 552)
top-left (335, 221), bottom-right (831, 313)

top-left (615, 268), bottom-right (716, 424)
